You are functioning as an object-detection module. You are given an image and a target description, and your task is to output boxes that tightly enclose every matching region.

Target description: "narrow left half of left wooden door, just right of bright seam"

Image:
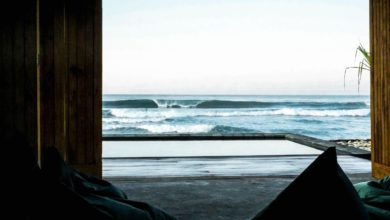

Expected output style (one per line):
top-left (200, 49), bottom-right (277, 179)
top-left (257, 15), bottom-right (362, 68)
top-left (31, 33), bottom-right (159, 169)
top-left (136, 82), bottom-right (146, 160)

top-left (40, 0), bottom-right (67, 159)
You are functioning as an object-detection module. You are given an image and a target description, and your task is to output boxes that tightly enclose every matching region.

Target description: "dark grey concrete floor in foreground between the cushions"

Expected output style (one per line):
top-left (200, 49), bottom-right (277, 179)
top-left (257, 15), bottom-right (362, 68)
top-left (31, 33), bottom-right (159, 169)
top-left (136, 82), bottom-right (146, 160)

top-left (106, 173), bottom-right (371, 220)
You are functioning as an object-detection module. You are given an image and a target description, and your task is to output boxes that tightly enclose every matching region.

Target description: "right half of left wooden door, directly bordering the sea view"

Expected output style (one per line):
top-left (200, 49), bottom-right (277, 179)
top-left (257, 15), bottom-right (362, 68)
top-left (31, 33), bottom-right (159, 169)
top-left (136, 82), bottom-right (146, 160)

top-left (66, 0), bottom-right (102, 176)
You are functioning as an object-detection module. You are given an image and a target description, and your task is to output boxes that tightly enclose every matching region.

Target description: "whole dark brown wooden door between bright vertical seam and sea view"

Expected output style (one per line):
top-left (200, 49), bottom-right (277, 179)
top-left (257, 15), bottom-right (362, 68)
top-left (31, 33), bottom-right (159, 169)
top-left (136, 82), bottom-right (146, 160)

top-left (40, 0), bottom-right (102, 176)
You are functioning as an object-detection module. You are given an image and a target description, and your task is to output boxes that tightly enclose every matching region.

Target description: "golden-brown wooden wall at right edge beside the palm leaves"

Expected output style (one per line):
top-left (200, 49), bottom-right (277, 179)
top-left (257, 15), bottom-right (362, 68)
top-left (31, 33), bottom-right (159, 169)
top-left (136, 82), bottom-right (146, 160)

top-left (370, 0), bottom-right (390, 178)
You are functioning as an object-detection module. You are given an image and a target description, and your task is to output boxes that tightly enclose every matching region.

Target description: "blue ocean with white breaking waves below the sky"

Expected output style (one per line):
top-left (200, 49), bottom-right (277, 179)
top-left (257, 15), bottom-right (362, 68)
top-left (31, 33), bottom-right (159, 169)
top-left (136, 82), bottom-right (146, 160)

top-left (103, 95), bottom-right (370, 140)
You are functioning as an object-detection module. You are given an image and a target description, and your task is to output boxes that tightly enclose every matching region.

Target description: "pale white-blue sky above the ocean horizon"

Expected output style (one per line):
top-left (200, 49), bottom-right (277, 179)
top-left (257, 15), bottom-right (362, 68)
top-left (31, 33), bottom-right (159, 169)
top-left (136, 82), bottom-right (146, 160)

top-left (103, 0), bottom-right (369, 95)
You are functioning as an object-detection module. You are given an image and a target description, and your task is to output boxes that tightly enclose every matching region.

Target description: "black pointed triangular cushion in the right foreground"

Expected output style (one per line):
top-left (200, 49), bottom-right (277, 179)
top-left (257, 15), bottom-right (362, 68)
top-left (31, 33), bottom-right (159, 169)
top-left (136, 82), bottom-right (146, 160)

top-left (253, 148), bottom-right (368, 220)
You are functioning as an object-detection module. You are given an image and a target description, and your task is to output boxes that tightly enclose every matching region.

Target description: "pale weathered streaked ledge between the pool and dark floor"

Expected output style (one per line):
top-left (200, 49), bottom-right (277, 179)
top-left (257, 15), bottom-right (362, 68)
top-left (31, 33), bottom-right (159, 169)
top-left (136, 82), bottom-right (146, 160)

top-left (103, 155), bottom-right (371, 178)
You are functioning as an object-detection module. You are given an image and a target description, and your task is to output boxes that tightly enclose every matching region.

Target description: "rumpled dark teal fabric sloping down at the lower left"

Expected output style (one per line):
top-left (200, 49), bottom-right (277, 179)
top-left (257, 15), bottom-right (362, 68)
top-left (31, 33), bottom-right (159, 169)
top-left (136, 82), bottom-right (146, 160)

top-left (42, 148), bottom-right (175, 220)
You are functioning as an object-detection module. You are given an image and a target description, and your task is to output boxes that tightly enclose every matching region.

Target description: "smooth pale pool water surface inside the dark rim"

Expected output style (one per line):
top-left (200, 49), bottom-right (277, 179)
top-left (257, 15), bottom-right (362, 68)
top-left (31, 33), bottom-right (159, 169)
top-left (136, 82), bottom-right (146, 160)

top-left (103, 140), bottom-right (322, 158)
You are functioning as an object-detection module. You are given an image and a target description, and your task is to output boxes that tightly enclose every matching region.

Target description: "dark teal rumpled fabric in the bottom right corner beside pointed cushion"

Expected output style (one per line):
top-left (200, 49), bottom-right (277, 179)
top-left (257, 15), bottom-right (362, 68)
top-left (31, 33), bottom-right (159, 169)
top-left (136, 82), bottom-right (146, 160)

top-left (354, 176), bottom-right (390, 220)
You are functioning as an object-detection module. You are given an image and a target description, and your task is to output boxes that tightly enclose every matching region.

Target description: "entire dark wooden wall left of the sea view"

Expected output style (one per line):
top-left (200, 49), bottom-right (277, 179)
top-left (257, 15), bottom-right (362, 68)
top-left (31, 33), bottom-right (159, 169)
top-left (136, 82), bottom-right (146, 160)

top-left (0, 0), bottom-right (102, 176)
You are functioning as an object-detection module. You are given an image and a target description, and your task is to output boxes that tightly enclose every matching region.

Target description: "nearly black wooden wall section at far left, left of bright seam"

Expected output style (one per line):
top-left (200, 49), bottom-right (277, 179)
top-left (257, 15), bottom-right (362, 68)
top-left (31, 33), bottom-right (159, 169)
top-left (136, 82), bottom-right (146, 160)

top-left (0, 0), bottom-right (39, 156)
